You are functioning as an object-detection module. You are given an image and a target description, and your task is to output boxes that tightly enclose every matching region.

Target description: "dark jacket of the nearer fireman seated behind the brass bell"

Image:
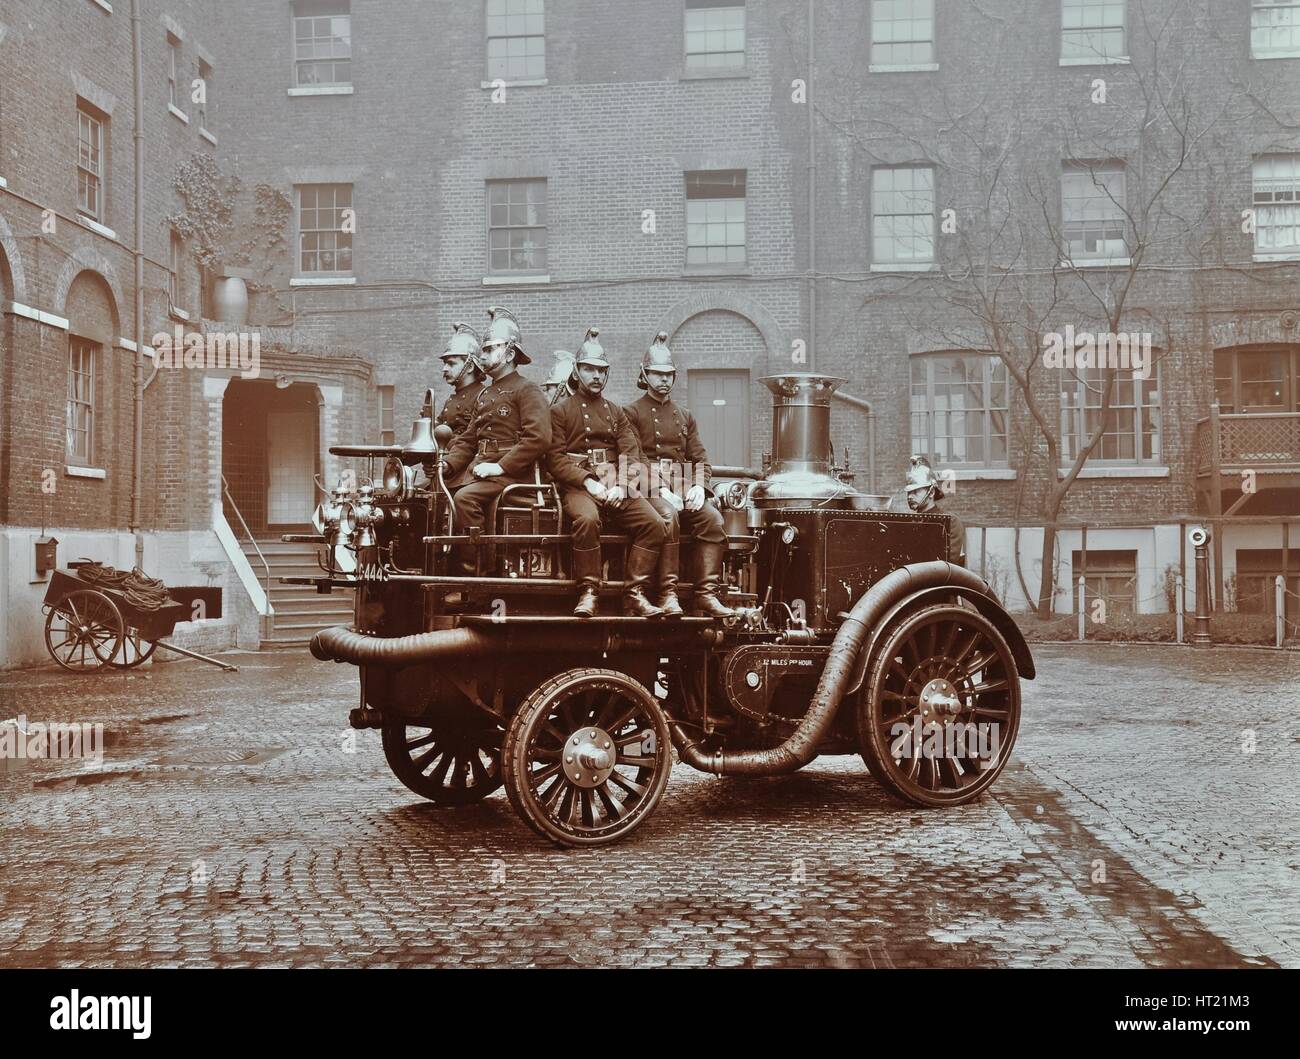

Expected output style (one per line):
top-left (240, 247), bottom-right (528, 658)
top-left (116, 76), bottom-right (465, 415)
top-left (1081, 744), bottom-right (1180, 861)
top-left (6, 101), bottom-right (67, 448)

top-left (447, 372), bottom-right (551, 482)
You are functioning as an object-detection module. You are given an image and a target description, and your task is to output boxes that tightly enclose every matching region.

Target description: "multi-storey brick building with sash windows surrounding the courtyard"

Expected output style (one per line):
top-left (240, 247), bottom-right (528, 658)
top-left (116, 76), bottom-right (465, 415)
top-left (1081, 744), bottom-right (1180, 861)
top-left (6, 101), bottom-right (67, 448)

top-left (0, 0), bottom-right (1300, 665)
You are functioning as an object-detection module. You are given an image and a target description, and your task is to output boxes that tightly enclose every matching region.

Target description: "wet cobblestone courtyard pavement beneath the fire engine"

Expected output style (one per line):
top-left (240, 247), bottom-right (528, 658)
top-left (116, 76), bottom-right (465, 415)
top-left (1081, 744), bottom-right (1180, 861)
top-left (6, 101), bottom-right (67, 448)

top-left (0, 644), bottom-right (1300, 967)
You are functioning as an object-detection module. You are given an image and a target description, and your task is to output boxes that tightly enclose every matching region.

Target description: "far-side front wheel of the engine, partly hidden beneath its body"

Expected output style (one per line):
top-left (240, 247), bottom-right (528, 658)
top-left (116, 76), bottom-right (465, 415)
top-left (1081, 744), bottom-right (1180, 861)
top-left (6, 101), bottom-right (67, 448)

top-left (384, 719), bottom-right (502, 806)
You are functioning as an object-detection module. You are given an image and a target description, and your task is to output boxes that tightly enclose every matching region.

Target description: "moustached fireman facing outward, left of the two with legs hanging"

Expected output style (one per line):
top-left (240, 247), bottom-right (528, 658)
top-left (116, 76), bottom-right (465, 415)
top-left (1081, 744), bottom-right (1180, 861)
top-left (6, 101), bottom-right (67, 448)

top-left (550, 327), bottom-right (667, 617)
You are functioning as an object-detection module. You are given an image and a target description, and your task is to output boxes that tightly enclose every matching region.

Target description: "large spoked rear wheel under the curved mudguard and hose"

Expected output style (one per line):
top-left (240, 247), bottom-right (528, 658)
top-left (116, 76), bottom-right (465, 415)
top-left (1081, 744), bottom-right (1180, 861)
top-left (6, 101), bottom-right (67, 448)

top-left (858, 603), bottom-right (1021, 806)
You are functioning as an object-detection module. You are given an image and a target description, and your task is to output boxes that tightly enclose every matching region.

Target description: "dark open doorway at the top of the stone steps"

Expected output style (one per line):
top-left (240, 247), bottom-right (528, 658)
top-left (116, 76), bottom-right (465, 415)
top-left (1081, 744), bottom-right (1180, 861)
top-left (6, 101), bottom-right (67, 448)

top-left (221, 379), bottom-right (320, 537)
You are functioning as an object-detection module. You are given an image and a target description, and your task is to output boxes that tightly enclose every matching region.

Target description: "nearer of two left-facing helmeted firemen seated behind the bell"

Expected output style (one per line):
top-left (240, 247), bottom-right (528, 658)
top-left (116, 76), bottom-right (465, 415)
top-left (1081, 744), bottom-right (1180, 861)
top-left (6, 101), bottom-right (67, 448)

top-left (446, 307), bottom-right (551, 572)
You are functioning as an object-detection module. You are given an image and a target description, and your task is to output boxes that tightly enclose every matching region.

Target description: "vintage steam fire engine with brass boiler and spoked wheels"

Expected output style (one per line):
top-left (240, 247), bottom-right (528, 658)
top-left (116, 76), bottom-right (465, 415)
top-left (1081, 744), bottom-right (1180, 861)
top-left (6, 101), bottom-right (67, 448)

top-left (295, 373), bottom-right (1034, 846)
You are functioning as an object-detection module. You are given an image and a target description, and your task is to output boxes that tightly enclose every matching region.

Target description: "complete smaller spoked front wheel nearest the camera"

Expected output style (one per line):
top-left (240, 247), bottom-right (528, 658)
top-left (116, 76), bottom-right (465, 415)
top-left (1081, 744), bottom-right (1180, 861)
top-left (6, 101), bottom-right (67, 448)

top-left (504, 669), bottom-right (672, 846)
